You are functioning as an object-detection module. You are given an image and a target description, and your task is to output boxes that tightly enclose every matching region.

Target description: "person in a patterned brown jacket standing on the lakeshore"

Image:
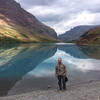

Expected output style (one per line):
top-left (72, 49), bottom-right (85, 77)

top-left (56, 58), bottom-right (67, 90)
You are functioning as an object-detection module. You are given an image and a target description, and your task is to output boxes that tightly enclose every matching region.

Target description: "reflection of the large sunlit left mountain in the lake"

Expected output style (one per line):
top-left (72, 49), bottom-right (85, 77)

top-left (0, 45), bottom-right (57, 96)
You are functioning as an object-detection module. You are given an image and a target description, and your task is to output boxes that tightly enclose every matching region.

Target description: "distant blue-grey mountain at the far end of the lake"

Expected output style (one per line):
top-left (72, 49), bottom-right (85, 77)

top-left (59, 25), bottom-right (95, 42)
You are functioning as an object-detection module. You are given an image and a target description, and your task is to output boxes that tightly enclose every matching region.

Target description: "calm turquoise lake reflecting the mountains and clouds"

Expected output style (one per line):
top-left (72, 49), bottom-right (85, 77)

top-left (0, 43), bottom-right (100, 96)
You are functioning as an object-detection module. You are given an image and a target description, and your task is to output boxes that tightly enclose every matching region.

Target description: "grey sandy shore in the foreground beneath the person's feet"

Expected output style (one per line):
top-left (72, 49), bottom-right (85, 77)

top-left (0, 81), bottom-right (100, 100)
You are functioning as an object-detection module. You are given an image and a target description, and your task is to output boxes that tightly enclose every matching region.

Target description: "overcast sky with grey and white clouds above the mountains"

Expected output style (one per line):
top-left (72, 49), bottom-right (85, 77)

top-left (16, 0), bottom-right (100, 34)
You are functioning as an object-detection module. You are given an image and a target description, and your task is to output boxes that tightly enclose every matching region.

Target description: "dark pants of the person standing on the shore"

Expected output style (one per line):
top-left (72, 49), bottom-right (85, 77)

top-left (58, 75), bottom-right (66, 90)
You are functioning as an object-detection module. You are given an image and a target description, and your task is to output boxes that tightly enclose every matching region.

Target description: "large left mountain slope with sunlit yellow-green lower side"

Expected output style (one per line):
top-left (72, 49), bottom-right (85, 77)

top-left (0, 0), bottom-right (58, 42)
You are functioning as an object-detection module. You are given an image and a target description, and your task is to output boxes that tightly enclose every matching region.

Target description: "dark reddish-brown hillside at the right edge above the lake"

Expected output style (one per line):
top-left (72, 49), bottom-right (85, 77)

top-left (77, 26), bottom-right (100, 44)
